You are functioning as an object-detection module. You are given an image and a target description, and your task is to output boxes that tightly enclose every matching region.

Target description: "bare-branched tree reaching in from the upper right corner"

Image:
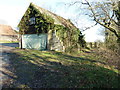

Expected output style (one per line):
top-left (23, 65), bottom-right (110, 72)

top-left (70, 0), bottom-right (120, 41)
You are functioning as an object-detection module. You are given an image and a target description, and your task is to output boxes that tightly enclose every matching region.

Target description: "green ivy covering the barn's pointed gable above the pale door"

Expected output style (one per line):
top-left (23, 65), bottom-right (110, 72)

top-left (18, 4), bottom-right (54, 34)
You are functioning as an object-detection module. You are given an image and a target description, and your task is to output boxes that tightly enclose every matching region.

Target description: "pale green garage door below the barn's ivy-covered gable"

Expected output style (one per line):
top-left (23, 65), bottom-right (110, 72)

top-left (22, 34), bottom-right (47, 50)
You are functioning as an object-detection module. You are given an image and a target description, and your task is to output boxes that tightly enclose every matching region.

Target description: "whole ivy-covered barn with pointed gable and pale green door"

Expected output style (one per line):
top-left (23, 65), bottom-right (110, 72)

top-left (18, 3), bottom-right (85, 52)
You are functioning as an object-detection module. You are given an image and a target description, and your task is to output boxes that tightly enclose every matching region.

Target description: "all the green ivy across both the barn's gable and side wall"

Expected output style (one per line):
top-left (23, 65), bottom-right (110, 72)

top-left (18, 4), bottom-right (85, 51)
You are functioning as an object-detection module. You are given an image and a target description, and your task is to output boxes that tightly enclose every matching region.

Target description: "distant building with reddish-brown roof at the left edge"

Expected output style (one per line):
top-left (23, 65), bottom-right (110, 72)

top-left (0, 24), bottom-right (18, 42)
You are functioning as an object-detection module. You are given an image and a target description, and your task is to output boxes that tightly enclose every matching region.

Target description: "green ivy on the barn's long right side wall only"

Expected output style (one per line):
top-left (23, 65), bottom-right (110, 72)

top-left (54, 25), bottom-right (86, 52)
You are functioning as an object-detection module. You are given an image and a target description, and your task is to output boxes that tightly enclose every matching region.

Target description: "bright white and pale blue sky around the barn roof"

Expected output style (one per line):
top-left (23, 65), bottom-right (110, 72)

top-left (0, 0), bottom-right (104, 42)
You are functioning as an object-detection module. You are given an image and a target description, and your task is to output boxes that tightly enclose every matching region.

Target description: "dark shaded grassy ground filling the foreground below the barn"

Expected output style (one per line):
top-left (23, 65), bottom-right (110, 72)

top-left (3, 51), bottom-right (120, 88)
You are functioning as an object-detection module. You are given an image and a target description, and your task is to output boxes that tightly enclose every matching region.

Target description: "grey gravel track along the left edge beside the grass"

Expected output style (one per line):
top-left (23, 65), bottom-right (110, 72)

top-left (0, 43), bottom-right (18, 89)
